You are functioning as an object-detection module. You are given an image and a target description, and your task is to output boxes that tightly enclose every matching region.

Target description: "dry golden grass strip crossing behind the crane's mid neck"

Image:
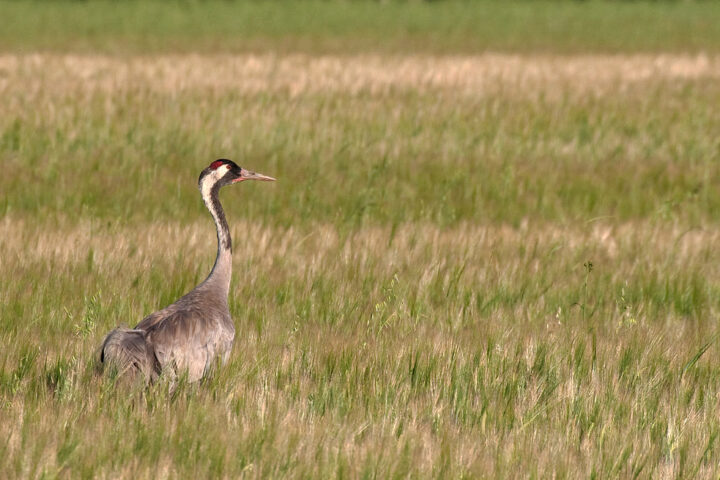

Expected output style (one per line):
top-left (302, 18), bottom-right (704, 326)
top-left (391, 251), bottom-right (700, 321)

top-left (0, 216), bottom-right (720, 275)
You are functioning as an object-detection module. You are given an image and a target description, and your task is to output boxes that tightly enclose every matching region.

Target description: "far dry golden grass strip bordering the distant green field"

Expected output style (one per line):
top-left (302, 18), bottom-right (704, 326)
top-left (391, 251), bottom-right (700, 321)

top-left (0, 54), bottom-right (720, 96)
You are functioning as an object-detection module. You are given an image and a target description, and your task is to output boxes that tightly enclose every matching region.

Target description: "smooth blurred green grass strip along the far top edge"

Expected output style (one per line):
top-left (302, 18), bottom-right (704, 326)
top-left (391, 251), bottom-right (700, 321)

top-left (0, 0), bottom-right (720, 53)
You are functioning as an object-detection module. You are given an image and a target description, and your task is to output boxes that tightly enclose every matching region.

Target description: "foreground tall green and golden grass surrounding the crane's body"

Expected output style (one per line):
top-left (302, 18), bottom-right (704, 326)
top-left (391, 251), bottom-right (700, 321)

top-left (0, 219), bottom-right (720, 477)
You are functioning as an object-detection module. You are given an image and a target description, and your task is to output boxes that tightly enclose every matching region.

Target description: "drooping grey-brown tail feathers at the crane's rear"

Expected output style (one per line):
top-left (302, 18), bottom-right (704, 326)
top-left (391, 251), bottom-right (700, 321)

top-left (100, 327), bottom-right (159, 380)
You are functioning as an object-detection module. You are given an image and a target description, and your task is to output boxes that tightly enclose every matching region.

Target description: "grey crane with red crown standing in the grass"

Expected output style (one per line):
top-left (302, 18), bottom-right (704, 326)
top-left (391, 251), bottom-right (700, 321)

top-left (100, 158), bottom-right (275, 383)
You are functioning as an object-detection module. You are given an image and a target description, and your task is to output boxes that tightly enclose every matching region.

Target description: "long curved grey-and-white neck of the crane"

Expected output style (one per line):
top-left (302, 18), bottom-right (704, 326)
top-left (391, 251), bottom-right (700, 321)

top-left (201, 183), bottom-right (232, 299)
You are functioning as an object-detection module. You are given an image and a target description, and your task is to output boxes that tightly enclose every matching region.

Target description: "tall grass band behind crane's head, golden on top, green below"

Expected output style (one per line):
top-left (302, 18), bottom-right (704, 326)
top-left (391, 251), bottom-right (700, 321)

top-left (0, 56), bottom-right (720, 228)
